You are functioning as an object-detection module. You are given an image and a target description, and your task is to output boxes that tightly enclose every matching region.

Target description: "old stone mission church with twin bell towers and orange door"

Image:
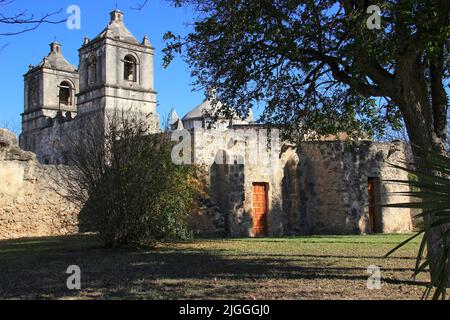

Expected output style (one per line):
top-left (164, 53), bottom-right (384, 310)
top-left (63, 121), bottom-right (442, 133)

top-left (13, 10), bottom-right (412, 236)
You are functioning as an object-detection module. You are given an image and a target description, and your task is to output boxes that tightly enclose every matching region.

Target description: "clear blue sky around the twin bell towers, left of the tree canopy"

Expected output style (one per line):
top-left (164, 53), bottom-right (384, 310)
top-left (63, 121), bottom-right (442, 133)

top-left (0, 0), bottom-right (204, 131)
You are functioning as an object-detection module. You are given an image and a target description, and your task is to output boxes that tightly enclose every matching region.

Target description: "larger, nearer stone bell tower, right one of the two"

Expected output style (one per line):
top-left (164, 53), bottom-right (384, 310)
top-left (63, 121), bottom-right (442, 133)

top-left (77, 10), bottom-right (159, 132)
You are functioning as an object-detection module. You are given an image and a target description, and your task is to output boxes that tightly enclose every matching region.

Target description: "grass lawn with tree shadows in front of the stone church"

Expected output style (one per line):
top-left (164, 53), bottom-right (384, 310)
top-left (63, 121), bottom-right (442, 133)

top-left (0, 235), bottom-right (428, 299)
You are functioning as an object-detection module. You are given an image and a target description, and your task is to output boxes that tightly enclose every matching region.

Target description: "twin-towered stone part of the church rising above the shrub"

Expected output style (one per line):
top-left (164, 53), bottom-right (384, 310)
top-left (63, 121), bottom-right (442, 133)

top-left (20, 10), bottom-right (159, 164)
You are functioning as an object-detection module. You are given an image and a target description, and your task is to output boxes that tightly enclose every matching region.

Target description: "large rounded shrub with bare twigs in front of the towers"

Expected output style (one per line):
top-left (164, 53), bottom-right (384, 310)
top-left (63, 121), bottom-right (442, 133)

top-left (58, 113), bottom-right (200, 246)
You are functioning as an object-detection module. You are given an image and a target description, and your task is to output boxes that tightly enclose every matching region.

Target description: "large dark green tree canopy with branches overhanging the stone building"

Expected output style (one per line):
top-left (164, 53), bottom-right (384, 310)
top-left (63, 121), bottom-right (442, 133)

top-left (164, 0), bottom-right (450, 153)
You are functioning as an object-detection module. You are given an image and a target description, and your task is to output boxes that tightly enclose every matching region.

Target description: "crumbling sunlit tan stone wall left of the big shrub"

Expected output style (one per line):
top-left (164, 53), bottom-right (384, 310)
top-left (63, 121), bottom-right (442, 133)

top-left (0, 129), bottom-right (79, 239)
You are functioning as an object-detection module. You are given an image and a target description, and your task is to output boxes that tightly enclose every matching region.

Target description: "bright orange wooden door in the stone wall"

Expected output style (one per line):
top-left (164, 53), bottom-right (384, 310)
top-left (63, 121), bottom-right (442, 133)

top-left (253, 183), bottom-right (267, 237)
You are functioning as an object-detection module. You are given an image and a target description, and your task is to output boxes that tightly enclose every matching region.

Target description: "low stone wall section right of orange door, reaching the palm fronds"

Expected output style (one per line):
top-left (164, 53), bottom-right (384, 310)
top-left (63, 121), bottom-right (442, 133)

top-left (293, 141), bottom-right (412, 234)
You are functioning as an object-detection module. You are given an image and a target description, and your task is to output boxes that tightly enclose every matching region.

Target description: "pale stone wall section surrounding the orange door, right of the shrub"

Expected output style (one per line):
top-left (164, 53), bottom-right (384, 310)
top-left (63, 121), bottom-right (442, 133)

top-left (190, 126), bottom-right (286, 237)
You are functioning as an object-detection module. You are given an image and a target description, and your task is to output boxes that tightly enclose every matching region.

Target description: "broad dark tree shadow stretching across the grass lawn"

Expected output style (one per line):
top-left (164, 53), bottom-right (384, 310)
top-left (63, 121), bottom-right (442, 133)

top-left (0, 235), bottom-right (426, 299)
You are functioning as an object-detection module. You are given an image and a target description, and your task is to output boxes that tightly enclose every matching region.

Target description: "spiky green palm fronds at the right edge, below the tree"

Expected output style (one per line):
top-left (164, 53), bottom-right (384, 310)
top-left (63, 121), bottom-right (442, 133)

top-left (382, 155), bottom-right (450, 299)
